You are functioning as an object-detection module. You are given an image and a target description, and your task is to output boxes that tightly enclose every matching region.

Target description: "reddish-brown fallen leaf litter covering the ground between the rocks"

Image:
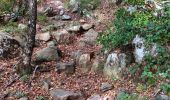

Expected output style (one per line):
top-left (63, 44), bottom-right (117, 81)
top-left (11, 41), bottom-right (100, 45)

top-left (0, 0), bottom-right (155, 100)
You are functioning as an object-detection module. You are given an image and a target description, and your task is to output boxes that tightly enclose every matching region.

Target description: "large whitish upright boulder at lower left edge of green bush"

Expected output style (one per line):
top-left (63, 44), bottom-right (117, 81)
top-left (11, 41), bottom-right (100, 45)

top-left (103, 52), bottom-right (126, 78)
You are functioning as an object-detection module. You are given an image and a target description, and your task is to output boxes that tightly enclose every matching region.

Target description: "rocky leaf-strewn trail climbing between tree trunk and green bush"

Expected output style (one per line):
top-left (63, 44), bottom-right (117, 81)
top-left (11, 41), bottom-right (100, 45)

top-left (0, 0), bottom-right (168, 100)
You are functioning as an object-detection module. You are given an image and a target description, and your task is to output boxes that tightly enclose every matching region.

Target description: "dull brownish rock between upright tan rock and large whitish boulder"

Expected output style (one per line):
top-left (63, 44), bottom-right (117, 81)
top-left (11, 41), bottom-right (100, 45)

top-left (91, 58), bottom-right (105, 74)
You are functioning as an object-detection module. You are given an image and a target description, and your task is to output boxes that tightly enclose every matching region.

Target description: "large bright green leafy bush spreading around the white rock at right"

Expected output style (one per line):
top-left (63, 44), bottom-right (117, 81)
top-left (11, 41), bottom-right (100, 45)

top-left (99, 0), bottom-right (170, 85)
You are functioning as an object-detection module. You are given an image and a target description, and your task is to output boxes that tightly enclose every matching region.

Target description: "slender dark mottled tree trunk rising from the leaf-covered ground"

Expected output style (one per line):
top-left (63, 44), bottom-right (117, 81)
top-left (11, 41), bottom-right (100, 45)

top-left (20, 0), bottom-right (37, 74)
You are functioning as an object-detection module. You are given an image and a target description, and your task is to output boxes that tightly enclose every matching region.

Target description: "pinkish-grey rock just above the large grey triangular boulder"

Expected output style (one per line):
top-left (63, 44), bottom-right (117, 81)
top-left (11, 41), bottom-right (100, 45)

top-left (52, 29), bottom-right (73, 44)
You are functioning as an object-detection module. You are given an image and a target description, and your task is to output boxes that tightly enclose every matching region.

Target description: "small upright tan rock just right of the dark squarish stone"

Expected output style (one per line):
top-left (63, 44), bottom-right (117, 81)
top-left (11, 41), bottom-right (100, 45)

top-left (79, 54), bottom-right (91, 73)
